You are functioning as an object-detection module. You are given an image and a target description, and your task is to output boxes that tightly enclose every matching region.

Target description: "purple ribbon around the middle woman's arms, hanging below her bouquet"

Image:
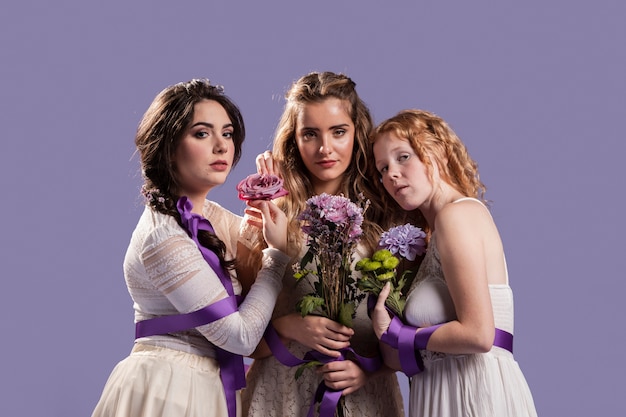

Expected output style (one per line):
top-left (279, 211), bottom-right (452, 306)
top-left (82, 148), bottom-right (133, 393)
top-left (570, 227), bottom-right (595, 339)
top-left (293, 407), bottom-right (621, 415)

top-left (264, 323), bottom-right (382, 417)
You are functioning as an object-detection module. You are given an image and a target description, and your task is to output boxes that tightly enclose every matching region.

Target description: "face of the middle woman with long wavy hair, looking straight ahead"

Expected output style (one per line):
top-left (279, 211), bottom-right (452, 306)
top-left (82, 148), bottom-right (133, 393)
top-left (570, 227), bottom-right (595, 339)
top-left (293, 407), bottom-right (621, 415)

top-left (296, 97), bottom-right (355, 194)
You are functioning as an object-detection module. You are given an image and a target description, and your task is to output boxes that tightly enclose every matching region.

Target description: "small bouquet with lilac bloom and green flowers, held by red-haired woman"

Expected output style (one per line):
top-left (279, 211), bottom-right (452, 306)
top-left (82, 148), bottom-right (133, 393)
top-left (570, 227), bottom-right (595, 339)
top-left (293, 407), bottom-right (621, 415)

top-left (355, 223), bottom-right (426, 317)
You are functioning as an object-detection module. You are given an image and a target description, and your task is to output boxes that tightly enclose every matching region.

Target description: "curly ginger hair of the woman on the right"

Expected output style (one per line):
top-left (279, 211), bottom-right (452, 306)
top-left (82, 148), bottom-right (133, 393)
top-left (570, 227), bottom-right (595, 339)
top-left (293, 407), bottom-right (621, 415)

top-left (370, 109), bottom-right (489, 224)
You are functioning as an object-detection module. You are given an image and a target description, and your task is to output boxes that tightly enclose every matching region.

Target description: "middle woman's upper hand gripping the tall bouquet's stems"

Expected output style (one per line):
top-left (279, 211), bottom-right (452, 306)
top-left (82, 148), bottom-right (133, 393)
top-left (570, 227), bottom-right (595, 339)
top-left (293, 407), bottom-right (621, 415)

top-left (273, 313), bottom-right (354, 358)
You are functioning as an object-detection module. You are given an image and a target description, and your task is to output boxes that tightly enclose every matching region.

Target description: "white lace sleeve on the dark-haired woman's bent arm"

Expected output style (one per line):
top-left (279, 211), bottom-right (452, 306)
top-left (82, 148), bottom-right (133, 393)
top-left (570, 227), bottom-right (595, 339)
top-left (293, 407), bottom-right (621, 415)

top-left (143, 231), bottom-right (289, 355)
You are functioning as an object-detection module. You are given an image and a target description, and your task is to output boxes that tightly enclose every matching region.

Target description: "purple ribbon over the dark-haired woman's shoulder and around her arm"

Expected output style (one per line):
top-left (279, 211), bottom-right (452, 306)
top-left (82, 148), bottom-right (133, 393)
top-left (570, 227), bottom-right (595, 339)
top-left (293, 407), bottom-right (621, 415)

top-left (135, 197), bottom-right (246, 417)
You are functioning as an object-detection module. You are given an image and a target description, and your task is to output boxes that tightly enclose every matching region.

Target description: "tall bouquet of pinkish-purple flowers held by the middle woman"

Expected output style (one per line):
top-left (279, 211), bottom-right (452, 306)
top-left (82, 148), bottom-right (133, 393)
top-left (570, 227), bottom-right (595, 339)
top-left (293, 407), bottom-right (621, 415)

top-left (294, 193), bottom-right (369, 327)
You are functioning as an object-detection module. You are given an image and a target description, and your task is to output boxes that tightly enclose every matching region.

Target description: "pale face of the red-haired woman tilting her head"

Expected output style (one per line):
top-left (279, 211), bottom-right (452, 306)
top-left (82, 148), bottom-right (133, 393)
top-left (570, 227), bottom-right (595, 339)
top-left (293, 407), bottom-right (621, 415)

top-left (373, 132), bottom-right (434, 210)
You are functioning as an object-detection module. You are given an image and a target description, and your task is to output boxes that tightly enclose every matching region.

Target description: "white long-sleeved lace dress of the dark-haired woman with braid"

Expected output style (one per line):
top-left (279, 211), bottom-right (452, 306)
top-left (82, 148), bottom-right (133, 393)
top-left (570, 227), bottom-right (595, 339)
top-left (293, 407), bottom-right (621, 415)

top-left (93, 201), bottom-right (289, 417)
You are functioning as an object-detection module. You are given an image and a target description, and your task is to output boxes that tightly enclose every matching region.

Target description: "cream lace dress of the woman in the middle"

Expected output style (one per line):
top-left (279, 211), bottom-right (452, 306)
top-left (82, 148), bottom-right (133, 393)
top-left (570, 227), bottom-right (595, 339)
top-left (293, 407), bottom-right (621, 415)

top-left (242, 244), bottom-right (404, 417)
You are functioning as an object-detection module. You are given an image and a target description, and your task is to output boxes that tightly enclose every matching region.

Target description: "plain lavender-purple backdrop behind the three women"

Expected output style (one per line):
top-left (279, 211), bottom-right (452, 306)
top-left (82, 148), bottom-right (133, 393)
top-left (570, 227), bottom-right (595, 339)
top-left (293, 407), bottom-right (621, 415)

top-left (0, 0), bottom-right (626, 416)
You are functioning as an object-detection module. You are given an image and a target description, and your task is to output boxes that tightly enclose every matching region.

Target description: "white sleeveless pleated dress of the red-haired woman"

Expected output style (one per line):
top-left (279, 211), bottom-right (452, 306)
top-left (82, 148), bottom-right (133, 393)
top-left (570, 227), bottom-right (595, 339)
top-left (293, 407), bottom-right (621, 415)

top-left (405, 200), bottom-right (537, 417)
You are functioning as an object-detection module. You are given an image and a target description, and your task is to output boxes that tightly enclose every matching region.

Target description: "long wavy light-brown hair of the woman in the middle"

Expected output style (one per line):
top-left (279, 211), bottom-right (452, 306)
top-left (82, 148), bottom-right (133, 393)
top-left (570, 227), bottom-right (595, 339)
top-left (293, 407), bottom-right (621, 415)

top-left (247, 72), bottom-right (391, 264)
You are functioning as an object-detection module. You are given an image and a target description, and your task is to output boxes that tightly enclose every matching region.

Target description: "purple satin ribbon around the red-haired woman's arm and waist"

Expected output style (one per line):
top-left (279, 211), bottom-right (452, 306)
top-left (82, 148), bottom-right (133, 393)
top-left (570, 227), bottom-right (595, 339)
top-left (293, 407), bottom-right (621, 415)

top-left (380, 311), bottom-right (513, 377)
